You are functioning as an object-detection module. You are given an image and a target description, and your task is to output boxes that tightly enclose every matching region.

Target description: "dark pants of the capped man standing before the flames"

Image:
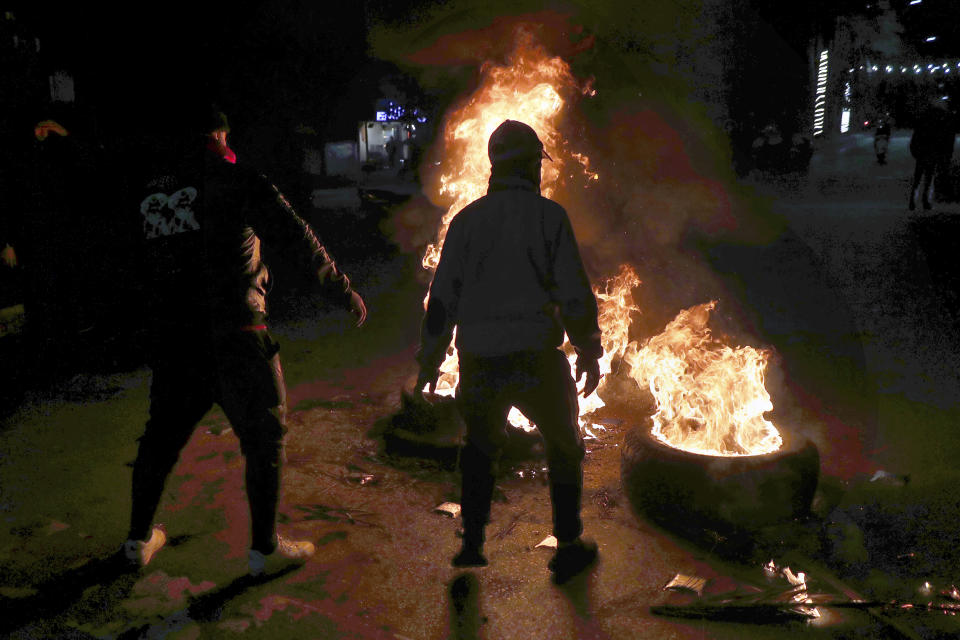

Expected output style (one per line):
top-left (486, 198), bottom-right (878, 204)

top-left (457, 349), bottom-right (584, 545)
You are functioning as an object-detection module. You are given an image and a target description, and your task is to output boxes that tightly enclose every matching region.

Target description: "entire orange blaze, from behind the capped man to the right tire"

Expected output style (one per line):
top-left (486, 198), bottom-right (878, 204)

top-left (423, 26), bottom-right (782, 456)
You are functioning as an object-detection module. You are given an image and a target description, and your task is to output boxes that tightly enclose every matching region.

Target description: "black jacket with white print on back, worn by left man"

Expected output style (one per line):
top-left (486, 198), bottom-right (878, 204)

top-left (134, 146), bottom-right (352, 335)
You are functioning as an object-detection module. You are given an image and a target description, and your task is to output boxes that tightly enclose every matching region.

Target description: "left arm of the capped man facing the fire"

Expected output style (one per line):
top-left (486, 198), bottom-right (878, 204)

top-left (414, 217), bottom-right (464, 392)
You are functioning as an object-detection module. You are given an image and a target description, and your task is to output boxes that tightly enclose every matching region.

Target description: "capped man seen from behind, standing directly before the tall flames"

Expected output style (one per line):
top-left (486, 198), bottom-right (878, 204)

top-left (417, 120), bottom-right (603, 583)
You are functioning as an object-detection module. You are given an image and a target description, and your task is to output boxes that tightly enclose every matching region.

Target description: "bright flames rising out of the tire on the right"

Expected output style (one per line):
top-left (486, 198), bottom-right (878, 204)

top-left (624, 301), bottom-right (783, 456)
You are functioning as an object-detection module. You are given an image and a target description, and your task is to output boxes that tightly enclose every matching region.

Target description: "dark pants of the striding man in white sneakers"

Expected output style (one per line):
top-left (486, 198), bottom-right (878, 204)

top-left (130, 330), bottom-right (286, 553)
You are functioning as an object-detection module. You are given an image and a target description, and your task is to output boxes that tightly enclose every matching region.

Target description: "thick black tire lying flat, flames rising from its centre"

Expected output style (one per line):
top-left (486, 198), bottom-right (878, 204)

top-left (621, 418), bottom-right (820, 529)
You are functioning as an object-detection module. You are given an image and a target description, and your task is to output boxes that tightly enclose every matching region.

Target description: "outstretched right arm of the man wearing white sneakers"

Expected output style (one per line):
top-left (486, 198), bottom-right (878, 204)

top-left (252, 176), bottom-right (367, 326)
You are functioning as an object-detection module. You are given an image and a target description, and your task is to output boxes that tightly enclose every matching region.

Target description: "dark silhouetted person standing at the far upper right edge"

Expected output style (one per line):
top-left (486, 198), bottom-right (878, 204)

top-left (908, 98), bottom-right (956, 211)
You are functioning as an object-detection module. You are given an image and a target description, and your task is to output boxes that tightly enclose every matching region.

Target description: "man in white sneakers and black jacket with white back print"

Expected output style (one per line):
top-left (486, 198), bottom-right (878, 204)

top-left (123, 107), bottom-right (366, 575)
